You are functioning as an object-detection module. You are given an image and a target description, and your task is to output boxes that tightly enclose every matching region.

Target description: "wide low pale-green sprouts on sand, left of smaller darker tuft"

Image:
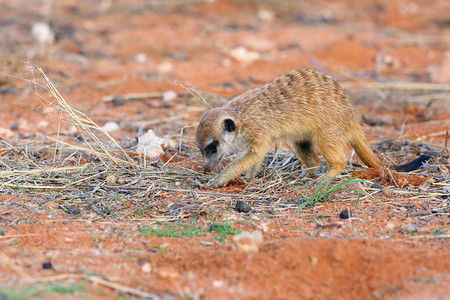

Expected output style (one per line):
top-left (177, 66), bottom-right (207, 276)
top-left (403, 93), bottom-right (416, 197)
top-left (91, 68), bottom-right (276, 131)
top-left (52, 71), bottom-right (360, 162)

top-left (139, 219), bottom-right (204, 238)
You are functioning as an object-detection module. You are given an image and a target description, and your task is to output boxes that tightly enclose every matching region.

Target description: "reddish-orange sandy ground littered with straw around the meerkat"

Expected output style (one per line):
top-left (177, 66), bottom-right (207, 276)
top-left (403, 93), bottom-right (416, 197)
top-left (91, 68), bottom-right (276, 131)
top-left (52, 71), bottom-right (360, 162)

top-left (0, 0), bottom-right (450, 299)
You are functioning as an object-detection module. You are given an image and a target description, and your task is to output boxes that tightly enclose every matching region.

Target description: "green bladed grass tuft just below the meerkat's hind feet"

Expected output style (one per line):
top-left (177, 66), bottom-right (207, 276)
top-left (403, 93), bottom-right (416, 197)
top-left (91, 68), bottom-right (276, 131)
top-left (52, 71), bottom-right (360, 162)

top-left (293, 177), bottom-right (365, 211)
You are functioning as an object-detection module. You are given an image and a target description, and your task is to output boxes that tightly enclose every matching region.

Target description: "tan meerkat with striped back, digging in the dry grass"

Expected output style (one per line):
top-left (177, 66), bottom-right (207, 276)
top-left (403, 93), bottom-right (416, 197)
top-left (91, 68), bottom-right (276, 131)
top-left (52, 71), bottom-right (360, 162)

top-left (197, 69), bottom-right (380, 188)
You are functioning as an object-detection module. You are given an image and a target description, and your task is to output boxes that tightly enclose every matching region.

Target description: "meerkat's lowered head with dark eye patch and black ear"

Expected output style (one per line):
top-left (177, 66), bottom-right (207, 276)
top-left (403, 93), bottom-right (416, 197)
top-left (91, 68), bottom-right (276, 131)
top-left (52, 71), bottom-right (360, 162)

top-left (197, 108), bottom-right (237, 171)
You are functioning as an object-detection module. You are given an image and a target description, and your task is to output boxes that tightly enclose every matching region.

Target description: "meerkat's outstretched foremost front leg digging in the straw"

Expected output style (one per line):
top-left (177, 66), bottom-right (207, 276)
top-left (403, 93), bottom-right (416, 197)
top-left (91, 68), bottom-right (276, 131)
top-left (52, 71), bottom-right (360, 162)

top-left (206, 149), bottom-right (265, 188)
